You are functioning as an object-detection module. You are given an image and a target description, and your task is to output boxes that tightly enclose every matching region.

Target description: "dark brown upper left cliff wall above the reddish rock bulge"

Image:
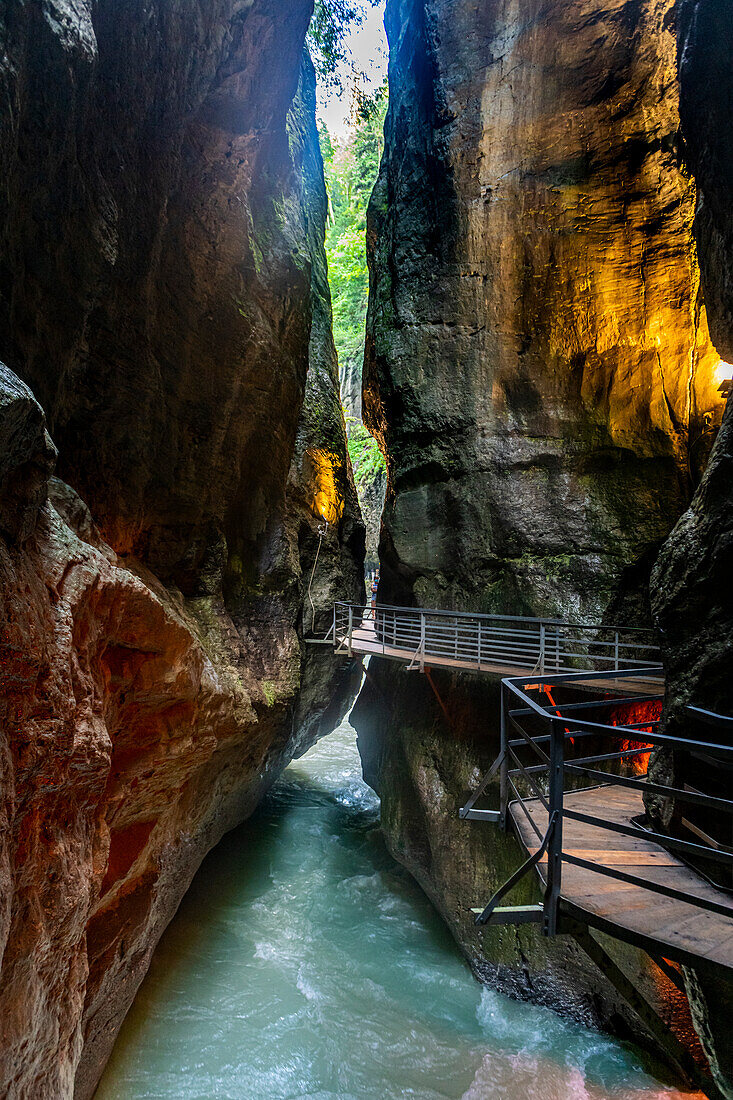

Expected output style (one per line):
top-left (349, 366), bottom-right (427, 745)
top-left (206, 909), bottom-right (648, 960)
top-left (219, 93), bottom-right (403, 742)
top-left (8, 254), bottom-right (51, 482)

top-left (0, 0), bottom-right (319, 593)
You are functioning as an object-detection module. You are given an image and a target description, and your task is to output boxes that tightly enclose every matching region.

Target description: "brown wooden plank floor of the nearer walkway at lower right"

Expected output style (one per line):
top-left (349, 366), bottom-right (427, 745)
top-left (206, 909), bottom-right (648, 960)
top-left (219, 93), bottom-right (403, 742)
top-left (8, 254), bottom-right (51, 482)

top-left (508, 787), bottom-right (733, 970)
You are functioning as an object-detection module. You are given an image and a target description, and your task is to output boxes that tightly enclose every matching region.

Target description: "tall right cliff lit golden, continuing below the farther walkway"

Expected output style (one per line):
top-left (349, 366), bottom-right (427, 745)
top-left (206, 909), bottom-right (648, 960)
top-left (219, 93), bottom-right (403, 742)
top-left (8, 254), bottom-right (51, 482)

top-left (353, 0), bottom-right (725, 1086)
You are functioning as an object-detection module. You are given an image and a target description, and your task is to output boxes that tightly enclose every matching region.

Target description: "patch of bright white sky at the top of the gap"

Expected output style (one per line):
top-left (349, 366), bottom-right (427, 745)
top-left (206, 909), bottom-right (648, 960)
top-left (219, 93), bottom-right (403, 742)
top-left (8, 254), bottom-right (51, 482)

top-left (316, 0), bottom-right (387, 141)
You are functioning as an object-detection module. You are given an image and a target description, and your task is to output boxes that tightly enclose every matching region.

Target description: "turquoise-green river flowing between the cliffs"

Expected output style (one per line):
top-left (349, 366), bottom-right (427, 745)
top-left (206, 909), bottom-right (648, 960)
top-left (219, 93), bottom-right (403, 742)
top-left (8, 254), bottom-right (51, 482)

top-left (96, 708), bottom-right (681, 1100)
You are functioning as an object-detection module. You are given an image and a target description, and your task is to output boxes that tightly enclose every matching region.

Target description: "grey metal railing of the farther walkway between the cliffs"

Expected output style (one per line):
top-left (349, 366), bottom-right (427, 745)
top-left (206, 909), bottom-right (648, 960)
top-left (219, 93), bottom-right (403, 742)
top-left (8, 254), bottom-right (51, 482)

top-left (329, 603), bottom-right (660, 675)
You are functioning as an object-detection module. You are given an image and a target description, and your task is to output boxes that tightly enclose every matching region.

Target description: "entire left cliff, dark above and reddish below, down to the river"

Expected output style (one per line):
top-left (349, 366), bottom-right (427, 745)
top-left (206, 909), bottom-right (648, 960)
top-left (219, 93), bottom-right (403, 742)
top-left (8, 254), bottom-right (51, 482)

top-left (0, 0), bottom-right (364, 1098)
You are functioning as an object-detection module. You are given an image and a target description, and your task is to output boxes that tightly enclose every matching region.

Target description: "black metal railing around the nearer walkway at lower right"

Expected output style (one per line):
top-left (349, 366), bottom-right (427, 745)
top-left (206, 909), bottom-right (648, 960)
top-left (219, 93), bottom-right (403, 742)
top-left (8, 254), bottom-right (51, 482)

top-left (461, 669), bottom-right (733, 936)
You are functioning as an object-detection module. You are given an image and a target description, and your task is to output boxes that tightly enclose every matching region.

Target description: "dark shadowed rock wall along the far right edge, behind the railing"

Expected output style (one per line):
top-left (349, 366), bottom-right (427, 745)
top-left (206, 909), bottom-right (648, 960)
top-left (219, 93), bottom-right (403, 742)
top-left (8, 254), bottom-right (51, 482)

top-left (652, 2), bottom-right (733, 1097)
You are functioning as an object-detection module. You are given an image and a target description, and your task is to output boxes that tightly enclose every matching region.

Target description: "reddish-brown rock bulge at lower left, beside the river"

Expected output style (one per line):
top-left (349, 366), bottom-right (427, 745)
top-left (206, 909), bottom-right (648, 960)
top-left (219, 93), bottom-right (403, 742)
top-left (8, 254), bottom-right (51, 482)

top-left (0, 466), bottom-right (254, 1097)
